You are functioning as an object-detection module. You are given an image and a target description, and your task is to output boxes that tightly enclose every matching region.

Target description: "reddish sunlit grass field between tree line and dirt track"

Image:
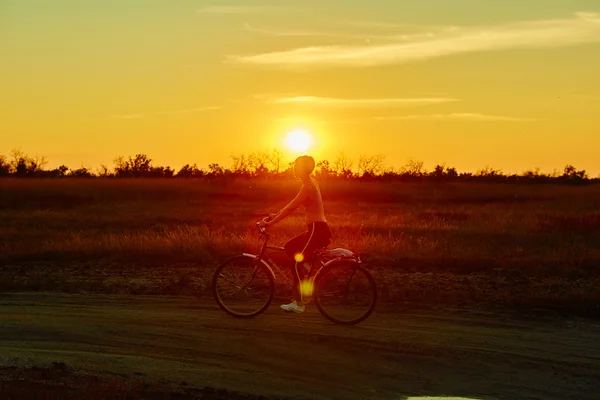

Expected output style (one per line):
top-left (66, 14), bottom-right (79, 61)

top-left (0, 179), bottom-right (600, 316)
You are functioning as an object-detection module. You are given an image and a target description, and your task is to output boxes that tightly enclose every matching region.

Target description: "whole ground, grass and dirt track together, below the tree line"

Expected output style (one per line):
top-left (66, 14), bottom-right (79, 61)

top-left (0, 179), bottom-right (600, 400)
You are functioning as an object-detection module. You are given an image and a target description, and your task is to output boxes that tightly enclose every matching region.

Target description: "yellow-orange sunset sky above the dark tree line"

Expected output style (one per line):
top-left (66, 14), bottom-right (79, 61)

top-left (0, 0), bottom-right (600, 176)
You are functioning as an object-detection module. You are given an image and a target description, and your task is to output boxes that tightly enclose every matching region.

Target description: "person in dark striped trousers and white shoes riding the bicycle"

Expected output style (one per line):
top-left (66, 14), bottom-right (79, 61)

top-left (258, 156), bottom-right (331, 313)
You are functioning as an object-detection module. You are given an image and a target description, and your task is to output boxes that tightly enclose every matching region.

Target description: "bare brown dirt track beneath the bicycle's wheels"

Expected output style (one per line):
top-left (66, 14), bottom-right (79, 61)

top-left (0, 294), bottom-right (600, 400)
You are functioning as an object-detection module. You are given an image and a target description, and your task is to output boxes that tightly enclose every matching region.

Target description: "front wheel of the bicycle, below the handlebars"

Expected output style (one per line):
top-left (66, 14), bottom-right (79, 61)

top-left (212, 255), bottom-right (275, 318)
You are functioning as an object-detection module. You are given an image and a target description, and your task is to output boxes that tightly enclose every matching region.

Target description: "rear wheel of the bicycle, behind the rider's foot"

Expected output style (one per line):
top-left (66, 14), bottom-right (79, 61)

top-left (313, 260), bottom-right (377, 325)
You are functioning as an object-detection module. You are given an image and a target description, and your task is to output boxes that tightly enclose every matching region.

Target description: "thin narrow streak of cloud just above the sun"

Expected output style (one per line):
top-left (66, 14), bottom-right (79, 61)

top-left (256, 96), bottom-right (458, 108)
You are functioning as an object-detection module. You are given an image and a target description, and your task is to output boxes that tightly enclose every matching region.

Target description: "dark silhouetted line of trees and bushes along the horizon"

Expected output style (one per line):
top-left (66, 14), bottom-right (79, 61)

top-left (0, 150), bottom-right (600, 184)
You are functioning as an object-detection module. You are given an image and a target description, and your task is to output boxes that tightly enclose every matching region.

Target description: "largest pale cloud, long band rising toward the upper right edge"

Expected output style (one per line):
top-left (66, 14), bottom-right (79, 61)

top-left (227, 12), bottom-right (600, 67)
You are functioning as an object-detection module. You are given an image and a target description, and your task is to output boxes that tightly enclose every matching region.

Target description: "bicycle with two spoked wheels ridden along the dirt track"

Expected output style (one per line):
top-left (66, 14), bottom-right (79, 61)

top-left (212, 222), bottom-right (377, 325)
